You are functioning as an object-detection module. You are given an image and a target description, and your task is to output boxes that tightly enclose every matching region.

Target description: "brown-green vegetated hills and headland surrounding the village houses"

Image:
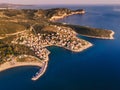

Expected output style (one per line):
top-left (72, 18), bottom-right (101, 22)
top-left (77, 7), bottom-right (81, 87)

top-left (0, 8), bottom-right (114, 63)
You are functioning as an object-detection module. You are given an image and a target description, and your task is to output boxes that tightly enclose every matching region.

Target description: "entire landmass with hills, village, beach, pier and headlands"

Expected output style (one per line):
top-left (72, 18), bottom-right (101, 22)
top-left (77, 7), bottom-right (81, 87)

top-left (0, 5), bottom-right (114, 80)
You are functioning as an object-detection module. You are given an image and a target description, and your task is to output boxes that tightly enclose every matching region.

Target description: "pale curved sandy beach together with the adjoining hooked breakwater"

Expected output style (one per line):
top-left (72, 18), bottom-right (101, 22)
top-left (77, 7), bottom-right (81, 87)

top-left (0, 56), bottom-right (48, 81)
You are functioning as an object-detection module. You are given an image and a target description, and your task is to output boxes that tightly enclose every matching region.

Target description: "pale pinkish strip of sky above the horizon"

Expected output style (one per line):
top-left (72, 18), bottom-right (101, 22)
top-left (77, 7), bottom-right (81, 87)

top-left (0, 0), bottom-right (120, 4)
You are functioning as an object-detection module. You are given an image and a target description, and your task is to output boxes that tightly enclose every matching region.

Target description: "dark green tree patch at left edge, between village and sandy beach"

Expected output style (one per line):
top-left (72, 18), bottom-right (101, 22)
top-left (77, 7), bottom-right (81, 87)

top-left (0, 40), bottom-right (34, 62)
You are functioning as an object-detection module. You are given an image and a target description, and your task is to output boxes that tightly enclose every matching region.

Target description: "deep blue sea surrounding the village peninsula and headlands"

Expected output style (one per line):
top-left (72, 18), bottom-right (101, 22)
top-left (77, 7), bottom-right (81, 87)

top-left (0, 5), bottom-right (120, 90)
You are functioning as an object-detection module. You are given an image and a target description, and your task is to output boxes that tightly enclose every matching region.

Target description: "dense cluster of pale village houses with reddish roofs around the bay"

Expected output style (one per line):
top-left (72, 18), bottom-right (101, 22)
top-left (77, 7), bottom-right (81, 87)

top-left (12, 25), bottom-right (91, 60)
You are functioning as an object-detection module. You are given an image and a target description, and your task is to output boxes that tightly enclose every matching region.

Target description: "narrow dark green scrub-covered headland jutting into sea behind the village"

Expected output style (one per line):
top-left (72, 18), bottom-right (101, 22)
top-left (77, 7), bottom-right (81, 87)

top-left (51, 22), bottom-right (112, 38)
